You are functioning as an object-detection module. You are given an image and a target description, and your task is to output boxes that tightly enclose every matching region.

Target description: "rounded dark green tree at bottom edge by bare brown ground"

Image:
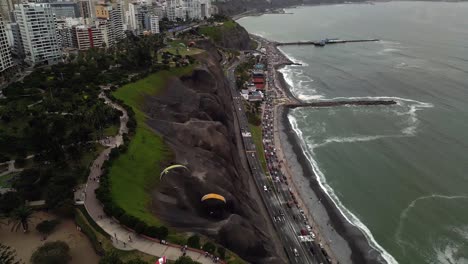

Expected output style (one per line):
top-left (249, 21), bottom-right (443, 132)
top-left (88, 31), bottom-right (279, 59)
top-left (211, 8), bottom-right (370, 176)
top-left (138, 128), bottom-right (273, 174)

top-left (31, 241), bottom-right (71, 264)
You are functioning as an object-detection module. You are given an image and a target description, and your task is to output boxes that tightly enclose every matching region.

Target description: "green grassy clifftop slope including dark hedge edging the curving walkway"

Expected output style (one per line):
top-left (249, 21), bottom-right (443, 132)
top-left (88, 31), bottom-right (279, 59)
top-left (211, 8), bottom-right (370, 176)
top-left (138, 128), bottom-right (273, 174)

top-left (97, 66), bottom-right (193, 243)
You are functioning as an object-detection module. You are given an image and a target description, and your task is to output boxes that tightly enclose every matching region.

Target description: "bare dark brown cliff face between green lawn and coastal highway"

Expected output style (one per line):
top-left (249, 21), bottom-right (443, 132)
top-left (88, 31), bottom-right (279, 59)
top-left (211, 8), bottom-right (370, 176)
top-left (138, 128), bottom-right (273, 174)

top-left (145, 53), bottom-right (282, 263)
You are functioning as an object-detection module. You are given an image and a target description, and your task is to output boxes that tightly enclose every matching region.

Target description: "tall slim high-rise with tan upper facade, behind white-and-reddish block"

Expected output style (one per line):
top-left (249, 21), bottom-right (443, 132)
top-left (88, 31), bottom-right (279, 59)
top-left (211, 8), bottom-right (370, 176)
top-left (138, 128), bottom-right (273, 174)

top-left (96, 3), bottom-right (125, 47)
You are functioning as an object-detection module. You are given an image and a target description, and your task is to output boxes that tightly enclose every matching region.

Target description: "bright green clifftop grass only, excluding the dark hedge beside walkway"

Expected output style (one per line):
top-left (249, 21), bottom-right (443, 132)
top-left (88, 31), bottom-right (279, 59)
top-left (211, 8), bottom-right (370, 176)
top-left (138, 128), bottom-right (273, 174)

top-left (109, 66), bottom-right (193, 228)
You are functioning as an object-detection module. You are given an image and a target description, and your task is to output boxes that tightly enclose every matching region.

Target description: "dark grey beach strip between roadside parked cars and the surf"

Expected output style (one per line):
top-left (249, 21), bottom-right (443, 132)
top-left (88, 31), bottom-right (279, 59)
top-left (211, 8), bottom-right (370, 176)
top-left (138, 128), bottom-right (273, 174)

top-left (255, 33), bottom-right (386, 264)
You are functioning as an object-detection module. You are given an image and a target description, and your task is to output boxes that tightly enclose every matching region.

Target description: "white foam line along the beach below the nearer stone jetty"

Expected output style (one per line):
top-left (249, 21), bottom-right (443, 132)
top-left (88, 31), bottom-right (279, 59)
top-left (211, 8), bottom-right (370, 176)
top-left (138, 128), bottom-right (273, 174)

top-left (288, 115), bottom-right (398, 264)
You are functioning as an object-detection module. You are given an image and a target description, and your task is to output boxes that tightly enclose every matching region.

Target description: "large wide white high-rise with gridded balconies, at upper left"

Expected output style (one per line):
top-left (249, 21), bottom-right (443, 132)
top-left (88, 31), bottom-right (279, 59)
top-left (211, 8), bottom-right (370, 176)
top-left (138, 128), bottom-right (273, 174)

top-left (15, 3), bottom-right (62, 65)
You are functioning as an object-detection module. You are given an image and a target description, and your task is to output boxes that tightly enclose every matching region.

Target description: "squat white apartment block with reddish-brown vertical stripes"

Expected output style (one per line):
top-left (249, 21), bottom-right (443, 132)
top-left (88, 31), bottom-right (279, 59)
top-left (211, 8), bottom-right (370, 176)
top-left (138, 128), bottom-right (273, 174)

top-left (72, 25), bottom-right (104, 50)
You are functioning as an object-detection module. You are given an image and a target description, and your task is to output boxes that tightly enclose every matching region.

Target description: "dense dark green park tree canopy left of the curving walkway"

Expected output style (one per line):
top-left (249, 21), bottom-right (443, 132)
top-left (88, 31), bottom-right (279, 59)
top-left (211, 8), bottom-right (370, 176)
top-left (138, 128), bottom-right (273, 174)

top-left (0, 35), bottom-right (167, 215)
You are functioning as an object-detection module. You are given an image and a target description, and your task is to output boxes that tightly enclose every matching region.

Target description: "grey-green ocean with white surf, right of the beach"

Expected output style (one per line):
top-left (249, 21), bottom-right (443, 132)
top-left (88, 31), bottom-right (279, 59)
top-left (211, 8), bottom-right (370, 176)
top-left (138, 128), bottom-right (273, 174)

top-left (238, 2), bottom-right (468, 264)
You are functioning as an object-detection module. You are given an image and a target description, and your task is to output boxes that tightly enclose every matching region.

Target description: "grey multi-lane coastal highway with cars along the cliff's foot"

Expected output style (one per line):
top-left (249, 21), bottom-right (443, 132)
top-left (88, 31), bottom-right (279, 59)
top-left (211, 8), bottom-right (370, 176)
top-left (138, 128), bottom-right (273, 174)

top-left (226, 61), bottom-right (320, 264)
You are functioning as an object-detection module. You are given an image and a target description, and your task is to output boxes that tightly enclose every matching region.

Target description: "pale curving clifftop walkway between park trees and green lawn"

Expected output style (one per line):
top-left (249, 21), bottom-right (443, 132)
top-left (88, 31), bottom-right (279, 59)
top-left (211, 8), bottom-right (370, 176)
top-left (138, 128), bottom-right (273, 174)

top-left (79, 93), bottom-right (218, 264)
